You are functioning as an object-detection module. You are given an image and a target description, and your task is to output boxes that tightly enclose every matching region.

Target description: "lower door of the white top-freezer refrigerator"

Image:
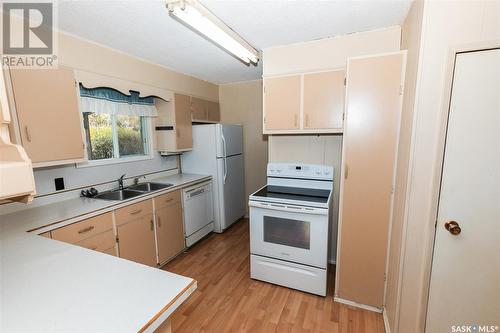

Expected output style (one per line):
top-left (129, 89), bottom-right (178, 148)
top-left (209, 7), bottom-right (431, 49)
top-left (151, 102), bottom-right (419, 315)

top-left (217, 155), bottom-right (245, 231)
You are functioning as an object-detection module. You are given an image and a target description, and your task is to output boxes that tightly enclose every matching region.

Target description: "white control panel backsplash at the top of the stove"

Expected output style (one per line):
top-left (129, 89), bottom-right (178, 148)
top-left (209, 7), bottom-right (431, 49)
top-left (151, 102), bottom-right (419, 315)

top-left (267, 163), bottom-right (333, 180)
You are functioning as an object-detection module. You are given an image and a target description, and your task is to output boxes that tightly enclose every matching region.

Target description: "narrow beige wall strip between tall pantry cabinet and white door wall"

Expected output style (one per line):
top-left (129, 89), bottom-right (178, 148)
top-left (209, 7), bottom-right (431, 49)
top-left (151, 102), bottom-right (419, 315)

top-left (384, 0), bottom-right (424, 332)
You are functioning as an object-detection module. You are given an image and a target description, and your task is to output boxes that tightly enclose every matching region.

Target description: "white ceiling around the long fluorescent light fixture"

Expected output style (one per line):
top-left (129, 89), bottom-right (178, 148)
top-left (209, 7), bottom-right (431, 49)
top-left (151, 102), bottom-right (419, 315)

top-left (58, 0), bottom-right (411, 84)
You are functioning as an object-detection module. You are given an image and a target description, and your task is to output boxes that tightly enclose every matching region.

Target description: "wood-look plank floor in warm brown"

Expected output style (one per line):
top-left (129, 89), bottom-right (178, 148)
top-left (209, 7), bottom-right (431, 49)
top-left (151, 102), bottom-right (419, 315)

top-left (163, 219), bottom-right (384, 333)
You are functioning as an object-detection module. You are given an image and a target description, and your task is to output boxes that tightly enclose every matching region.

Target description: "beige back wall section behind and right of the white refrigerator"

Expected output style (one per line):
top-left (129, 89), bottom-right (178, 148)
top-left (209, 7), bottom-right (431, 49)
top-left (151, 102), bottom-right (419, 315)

top-left (219, 80), bottom-right (267, 212)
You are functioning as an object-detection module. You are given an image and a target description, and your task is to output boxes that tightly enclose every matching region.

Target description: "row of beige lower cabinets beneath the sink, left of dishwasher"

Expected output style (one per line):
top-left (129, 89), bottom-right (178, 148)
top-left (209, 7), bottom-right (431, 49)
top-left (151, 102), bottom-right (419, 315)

top-left (40, 190), bottom-right (189, 267)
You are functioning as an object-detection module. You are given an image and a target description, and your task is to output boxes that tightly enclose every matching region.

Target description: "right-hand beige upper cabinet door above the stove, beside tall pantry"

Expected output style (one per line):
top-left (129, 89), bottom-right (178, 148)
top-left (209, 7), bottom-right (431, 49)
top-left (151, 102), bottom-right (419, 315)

top-left (303, 70), bottom-right (345, 132)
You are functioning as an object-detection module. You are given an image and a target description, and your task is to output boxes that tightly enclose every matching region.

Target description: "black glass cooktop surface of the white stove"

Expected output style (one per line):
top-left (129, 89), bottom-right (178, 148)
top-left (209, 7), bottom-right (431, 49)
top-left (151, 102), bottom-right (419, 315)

top-left (253, 185), bottom-right (330, 204)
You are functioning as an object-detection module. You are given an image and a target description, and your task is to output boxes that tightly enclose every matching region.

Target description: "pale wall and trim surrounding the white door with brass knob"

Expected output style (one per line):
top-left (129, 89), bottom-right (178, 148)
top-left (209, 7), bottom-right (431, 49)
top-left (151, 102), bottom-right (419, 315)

top-left (393, 1), bottom-right (500, 333)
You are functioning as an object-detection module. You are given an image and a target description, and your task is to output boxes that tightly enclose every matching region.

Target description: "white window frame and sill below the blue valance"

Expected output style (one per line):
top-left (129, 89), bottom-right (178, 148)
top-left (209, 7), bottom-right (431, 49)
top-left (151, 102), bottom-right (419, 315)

top-left (75, 114), bottom-right (155, 168)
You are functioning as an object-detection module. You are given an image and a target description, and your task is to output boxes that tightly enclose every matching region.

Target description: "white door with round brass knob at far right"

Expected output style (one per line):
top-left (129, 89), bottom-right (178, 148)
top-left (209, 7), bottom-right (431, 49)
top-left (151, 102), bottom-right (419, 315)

top-left (426, 49), bottom-right (500, 333)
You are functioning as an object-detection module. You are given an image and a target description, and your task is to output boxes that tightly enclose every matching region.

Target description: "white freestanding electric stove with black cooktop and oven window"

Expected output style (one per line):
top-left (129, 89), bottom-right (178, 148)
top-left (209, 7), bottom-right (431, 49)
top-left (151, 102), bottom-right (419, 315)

top-left (249, 163), bottom-right (333, 296)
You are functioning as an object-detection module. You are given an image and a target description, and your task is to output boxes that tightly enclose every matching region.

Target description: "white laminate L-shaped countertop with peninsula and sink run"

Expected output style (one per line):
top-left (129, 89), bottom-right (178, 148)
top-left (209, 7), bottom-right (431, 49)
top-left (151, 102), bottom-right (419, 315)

top-left (0, 174), bottom-right (210, 332)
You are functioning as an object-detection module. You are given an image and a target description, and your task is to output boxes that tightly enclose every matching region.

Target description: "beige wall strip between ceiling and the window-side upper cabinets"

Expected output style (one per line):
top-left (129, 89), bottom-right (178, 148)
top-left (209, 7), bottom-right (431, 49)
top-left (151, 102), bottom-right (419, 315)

top-left (58, 33), bottom-right (219, 101)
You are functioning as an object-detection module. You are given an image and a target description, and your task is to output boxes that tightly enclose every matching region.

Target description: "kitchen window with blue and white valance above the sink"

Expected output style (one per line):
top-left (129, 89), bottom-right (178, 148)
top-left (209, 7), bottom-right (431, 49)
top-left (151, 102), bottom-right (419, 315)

top-left (80, 85), bottom-right (157, 166)
